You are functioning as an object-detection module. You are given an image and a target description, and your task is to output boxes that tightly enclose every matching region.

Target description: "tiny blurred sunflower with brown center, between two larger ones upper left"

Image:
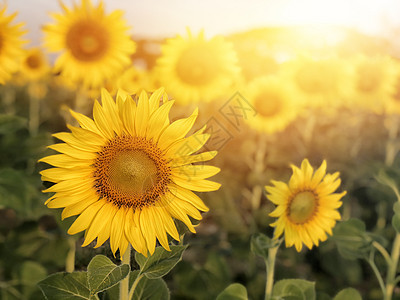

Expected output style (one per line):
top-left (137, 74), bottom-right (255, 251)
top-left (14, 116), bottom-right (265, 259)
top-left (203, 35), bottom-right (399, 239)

top-left (20, 48), bottom-right (50, 81)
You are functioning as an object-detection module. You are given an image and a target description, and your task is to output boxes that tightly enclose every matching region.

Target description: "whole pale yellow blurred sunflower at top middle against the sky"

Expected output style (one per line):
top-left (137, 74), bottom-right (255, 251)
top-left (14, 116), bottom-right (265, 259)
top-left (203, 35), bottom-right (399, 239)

top-left (156, 31), bottom-right (239, 103)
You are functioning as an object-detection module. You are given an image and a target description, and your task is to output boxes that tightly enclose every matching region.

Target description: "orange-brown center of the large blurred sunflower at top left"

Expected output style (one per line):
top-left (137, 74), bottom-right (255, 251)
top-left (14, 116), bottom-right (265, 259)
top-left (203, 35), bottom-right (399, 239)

top-left (66, 20), bottom-right (110, 61)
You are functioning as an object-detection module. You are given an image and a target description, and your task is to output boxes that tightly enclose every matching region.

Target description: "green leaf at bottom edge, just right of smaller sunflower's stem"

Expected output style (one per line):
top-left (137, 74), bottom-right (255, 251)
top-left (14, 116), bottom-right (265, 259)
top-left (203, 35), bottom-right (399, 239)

top-left (272, 279), bottom-right (315, 300)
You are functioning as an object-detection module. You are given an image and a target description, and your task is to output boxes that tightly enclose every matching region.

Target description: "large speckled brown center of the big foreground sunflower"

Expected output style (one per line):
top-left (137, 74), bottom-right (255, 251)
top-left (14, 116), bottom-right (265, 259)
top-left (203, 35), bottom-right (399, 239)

top-left (94, 136), bottom-right (171, 209)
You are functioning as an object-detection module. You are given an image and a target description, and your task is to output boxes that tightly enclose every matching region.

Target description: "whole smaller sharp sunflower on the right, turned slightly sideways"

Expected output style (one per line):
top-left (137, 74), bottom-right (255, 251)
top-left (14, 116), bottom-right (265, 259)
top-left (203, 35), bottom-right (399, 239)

top-left (265, 159), bottom-right (346, 252)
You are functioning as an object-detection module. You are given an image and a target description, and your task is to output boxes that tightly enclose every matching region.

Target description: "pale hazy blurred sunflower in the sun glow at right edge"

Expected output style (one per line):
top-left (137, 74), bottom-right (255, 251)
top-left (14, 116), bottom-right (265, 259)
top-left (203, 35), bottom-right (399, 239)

top-left (348, 55), bottom-right (398, 113)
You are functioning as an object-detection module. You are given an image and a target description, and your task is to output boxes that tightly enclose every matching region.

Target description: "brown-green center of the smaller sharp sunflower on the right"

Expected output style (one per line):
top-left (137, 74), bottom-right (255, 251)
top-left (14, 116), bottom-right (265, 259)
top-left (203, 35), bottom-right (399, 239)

top-left (287, 191), bottom-right (318, 224)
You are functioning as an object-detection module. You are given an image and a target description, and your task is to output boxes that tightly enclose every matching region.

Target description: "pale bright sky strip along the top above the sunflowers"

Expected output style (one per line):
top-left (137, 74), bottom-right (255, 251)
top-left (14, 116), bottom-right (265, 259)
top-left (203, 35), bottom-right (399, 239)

top-left (7, 0), bottom-right (400, 45)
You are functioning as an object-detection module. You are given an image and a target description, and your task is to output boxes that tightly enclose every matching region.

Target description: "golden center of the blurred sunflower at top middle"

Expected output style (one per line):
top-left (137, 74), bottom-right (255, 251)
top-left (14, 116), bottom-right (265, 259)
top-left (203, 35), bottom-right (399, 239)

top-left (176, 46), bottom-right (219, 85)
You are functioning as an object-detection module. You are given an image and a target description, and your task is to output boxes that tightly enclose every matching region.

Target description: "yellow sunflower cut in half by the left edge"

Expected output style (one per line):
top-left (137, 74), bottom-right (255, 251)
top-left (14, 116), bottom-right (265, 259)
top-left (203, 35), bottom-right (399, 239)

top-left (0, 6), bottom-right (24, 84)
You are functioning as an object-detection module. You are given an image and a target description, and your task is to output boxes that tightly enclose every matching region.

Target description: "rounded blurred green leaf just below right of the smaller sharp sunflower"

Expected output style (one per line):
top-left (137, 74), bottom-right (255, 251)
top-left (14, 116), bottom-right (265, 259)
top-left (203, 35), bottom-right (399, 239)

top-left (333, 219), bottom-right (374, 259)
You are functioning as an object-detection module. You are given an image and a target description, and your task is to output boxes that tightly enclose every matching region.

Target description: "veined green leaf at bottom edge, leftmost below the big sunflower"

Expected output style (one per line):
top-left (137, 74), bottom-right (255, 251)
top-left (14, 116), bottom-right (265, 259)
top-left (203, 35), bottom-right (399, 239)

top-left (38, 272), bottom-right (96, 300)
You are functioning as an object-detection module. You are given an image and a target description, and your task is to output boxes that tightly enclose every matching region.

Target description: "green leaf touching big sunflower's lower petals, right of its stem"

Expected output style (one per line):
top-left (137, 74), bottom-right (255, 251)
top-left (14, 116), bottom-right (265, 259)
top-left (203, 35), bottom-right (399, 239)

top-left (135, 245), bottom-right (187, 279)
